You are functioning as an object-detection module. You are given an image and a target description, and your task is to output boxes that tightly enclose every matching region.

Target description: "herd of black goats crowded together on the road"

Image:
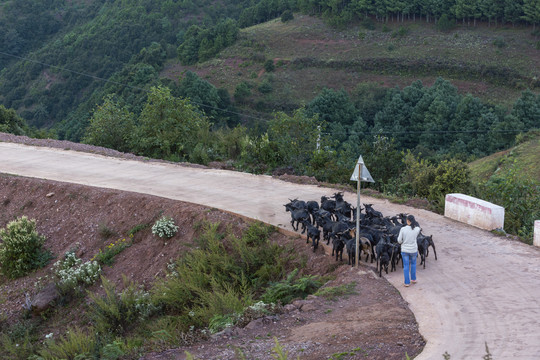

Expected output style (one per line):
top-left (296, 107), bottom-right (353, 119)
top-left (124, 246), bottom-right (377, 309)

top-left (284, 192), bottom-right (437, 276)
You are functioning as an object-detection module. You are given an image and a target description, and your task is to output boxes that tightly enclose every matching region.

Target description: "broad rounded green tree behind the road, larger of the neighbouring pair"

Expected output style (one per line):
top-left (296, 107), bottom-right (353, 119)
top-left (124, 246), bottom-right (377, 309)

top-left (136, 86), bottom-right (210, 160)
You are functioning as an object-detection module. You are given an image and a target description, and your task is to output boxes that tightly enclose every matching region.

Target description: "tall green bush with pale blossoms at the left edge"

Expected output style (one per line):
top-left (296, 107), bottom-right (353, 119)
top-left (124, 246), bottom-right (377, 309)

top-left (0, 216), bottom-right (52, 279)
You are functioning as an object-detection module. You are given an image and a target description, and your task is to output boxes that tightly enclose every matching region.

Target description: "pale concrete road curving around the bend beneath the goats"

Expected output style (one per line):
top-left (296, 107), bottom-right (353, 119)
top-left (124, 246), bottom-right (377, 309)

top-left (0, 143), bottom-right (540, 360)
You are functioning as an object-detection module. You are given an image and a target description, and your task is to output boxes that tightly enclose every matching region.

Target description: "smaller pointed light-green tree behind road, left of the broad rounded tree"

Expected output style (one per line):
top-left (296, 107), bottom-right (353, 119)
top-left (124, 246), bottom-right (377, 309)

top-left (83, 95), bottom-right (135, 152)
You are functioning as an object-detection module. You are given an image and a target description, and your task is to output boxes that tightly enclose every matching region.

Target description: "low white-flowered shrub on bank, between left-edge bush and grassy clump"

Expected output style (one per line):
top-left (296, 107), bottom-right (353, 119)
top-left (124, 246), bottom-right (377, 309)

top-left (53, 251), bottom-right (101, 293)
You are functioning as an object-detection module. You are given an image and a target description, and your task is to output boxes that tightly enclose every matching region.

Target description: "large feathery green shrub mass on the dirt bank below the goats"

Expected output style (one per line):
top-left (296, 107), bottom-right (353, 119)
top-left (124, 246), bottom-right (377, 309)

top-left (153, 222), bottom-right (288, 331)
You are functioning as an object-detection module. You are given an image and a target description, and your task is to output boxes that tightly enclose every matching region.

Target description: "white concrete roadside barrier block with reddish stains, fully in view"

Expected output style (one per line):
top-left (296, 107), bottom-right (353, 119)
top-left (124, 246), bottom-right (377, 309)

top-left (444, 194), bottom-right (504, 230)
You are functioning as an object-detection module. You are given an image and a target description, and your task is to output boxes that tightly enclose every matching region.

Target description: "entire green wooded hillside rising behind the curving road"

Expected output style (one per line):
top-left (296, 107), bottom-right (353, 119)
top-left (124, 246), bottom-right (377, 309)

top-left (0, 0), bottom-right (540, 242)
